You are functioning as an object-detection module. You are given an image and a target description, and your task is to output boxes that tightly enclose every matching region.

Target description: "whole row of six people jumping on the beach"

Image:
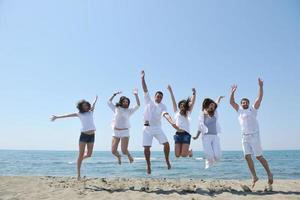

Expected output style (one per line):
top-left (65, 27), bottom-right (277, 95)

top-left (51, 71), bottom-right (273, 187)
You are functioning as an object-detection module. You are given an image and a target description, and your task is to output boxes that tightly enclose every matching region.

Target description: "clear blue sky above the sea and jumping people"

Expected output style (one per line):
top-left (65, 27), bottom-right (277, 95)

top-left (0, 0), bottom-right (300, 150)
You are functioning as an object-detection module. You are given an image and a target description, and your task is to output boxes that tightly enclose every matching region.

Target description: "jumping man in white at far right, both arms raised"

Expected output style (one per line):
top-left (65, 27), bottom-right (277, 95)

top-left (230, 78), bottom-right (273, 188)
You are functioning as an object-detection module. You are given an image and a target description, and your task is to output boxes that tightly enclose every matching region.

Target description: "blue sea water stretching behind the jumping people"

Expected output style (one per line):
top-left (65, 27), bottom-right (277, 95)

top-left (0, 150), bottom-right (300, 179)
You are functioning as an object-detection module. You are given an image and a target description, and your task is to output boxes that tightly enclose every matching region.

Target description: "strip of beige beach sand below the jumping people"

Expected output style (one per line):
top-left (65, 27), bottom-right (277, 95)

top-left (0, 176), bottom-right (300, 200)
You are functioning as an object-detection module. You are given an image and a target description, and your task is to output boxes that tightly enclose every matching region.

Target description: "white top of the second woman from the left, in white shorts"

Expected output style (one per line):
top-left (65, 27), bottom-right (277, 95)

top-left (107, 101), bottom-right (139, 129)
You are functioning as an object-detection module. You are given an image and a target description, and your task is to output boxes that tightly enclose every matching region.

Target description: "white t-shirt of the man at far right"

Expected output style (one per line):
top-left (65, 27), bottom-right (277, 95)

top-left (238, 106), bottom-right (259, 135)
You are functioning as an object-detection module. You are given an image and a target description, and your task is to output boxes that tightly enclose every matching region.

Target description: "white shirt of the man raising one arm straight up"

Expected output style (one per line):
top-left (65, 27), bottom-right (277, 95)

top-left (144, 92), bottom-right (167, 126)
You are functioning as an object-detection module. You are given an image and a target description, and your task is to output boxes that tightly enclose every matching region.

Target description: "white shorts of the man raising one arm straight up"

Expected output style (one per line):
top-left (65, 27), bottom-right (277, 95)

top-left (143, 126), bottom-right (168, 147)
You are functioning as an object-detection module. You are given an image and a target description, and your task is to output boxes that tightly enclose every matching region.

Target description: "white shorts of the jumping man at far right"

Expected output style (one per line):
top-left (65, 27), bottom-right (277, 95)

top-left (242, 133), bottom-right (262, 156)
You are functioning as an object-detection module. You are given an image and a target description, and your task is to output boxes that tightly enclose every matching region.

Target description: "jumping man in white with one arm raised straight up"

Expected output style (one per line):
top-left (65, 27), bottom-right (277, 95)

top-left (141, 71), bottom-right (179, 174)
